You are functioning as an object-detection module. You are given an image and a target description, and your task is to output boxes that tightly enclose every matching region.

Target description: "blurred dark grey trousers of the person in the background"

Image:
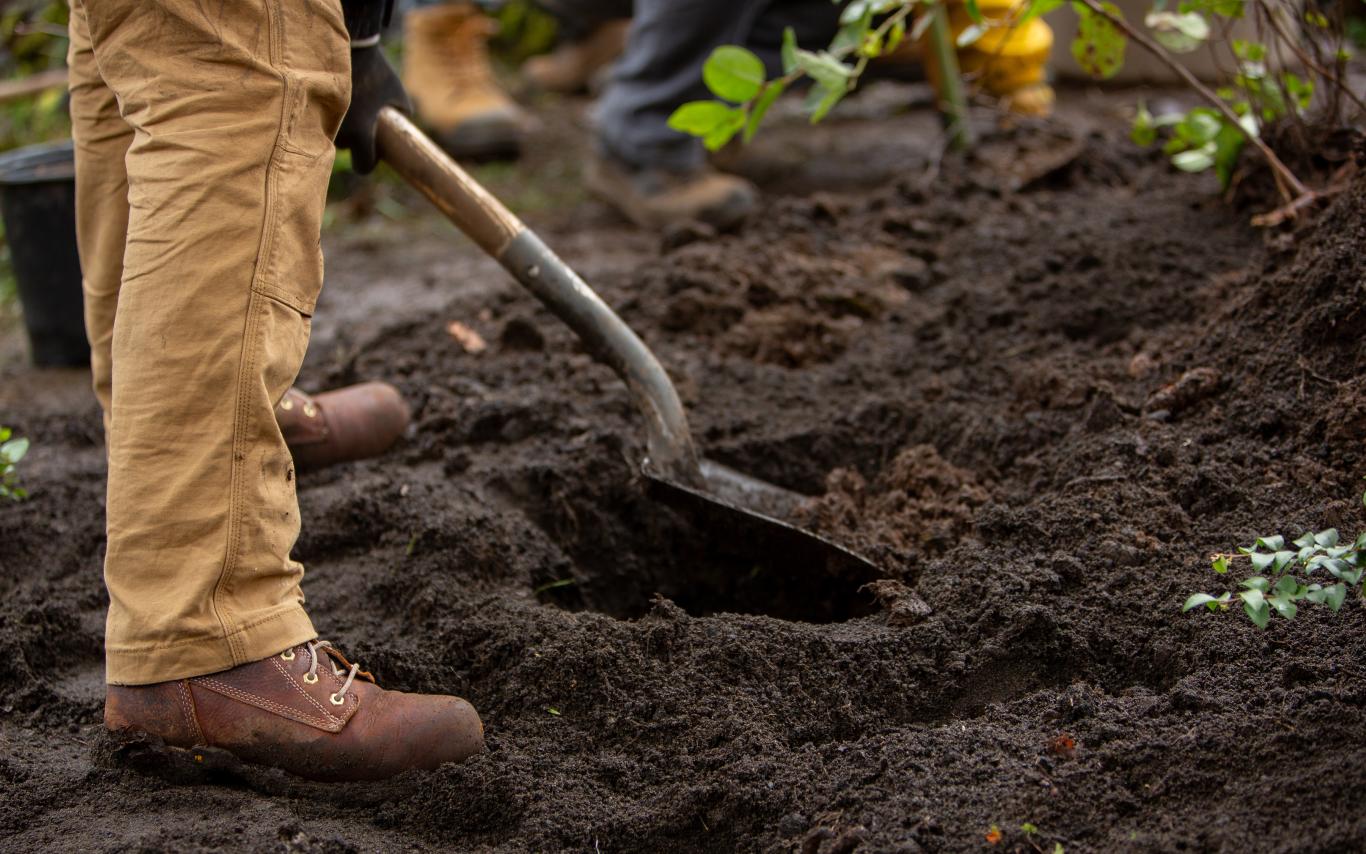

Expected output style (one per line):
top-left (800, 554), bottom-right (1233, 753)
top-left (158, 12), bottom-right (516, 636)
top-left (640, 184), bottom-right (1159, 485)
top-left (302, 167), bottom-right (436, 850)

top-left (601, 0), bottom-right (840, 172)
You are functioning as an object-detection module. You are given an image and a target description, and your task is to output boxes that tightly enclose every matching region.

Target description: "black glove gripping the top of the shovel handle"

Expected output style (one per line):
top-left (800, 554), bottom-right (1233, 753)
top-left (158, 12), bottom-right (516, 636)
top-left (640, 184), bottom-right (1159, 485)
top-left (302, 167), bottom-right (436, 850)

top-left (336, 0), bottom-right (413, 175)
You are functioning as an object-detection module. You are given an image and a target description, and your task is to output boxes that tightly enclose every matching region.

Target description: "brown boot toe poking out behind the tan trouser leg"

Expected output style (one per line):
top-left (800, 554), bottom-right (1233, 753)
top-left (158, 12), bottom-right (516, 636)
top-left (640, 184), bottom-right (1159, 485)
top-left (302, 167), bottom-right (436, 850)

top-left (275, 383), bottom-right (410, 471)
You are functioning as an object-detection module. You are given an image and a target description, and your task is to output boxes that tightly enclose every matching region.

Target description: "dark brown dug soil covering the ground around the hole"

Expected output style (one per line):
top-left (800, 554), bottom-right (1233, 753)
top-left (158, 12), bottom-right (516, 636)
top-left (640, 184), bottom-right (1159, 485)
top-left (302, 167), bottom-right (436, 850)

top-left (0, 88), bottom-right (1366, 853)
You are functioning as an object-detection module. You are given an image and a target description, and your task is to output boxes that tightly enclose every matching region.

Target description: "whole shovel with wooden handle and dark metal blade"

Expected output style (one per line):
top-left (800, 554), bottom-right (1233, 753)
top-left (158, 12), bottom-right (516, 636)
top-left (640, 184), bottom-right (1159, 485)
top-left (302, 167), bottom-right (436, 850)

top-left (377, 107), bottom-right (884, 589)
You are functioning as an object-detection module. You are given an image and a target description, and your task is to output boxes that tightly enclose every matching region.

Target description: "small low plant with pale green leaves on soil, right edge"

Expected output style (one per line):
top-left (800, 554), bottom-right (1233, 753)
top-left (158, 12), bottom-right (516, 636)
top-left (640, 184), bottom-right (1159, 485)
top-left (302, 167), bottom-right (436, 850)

top-left (1182, 527), bottom-right (1366, 629)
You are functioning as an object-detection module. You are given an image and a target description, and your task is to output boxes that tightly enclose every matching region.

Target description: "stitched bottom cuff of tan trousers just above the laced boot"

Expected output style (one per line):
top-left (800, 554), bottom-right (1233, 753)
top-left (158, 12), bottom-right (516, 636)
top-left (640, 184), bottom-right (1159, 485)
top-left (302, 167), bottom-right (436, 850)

top-left (104, 605), bottom-right (318, 685)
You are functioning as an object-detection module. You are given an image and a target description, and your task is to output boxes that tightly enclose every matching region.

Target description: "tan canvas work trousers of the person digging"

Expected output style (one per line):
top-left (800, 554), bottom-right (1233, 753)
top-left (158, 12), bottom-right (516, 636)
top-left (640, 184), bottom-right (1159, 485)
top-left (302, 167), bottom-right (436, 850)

top-left (70, 0), bottom-right (350, 685)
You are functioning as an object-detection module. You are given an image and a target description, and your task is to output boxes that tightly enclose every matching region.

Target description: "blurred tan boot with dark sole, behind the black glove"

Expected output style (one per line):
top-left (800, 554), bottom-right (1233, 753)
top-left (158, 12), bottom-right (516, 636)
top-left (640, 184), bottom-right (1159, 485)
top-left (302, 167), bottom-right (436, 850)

top-left (403, 3), bottom-right (527, 159)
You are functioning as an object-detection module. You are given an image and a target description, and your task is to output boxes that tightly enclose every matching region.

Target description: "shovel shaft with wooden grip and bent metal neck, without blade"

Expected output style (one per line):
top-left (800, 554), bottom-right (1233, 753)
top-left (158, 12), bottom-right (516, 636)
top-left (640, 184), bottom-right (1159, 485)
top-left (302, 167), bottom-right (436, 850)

top-left (376, 107), bottom-right (702, 485)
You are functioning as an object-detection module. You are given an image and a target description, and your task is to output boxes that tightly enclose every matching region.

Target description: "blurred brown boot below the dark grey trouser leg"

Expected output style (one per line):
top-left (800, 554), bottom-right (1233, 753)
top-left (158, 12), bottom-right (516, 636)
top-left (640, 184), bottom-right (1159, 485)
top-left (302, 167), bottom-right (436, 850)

top-left (587, 154), bottom-right (758, 230)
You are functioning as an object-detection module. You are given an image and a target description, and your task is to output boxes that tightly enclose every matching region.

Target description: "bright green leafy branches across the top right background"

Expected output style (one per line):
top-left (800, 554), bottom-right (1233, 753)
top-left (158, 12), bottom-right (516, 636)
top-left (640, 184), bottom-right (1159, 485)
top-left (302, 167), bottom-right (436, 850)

top-left (669, 0), bottom-right (1366, 225)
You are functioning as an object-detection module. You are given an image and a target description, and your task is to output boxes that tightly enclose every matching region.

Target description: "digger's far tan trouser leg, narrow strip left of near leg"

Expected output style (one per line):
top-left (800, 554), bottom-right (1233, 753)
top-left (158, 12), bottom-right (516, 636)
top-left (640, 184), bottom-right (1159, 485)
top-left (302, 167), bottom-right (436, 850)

top-left (67, 0), bottom-right (133, 430)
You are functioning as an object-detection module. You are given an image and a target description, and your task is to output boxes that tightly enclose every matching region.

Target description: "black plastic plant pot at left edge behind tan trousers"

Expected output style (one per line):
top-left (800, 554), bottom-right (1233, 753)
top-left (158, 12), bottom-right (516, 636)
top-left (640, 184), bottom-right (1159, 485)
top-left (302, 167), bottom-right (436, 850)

top-left (0, 141), bottom-right (90, 368)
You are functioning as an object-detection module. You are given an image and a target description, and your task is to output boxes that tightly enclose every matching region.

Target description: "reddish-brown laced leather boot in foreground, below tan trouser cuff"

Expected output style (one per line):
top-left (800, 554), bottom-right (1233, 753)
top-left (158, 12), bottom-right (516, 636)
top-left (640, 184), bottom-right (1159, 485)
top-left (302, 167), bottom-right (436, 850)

top-left (104, 641), bottom-right (484, 782)
